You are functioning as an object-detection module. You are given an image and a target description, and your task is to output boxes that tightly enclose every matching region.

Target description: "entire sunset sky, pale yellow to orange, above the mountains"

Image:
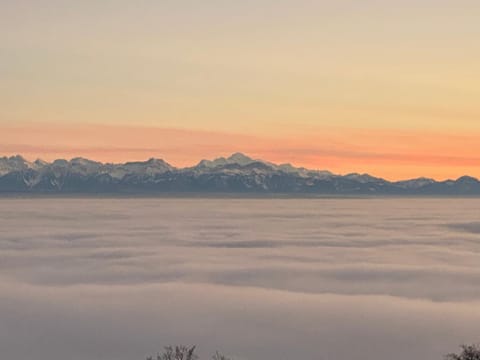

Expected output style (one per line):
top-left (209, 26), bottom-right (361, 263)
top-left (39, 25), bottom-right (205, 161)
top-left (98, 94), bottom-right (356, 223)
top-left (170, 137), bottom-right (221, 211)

top-left (0, 0), bottom-right (480, 179)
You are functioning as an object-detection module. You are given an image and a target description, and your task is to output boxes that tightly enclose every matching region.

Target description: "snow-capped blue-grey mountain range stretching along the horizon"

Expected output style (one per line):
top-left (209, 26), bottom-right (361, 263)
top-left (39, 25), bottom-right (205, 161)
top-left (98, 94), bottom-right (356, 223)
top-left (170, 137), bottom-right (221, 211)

top-left (0, 153), bottom-right (480, 196)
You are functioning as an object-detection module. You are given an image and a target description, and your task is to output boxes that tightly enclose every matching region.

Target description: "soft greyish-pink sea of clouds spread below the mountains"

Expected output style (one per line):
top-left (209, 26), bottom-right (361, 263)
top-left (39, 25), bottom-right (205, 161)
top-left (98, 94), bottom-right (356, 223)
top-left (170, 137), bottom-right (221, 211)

top-left (0, 198), bottom-right (480, 360)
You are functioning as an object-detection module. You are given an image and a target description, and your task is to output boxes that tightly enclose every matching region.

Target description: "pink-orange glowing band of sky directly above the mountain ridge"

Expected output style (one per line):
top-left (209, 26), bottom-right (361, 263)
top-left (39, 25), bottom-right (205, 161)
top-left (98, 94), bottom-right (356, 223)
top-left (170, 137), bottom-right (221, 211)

top-left (0, 124), bottom-right (480, 179)
